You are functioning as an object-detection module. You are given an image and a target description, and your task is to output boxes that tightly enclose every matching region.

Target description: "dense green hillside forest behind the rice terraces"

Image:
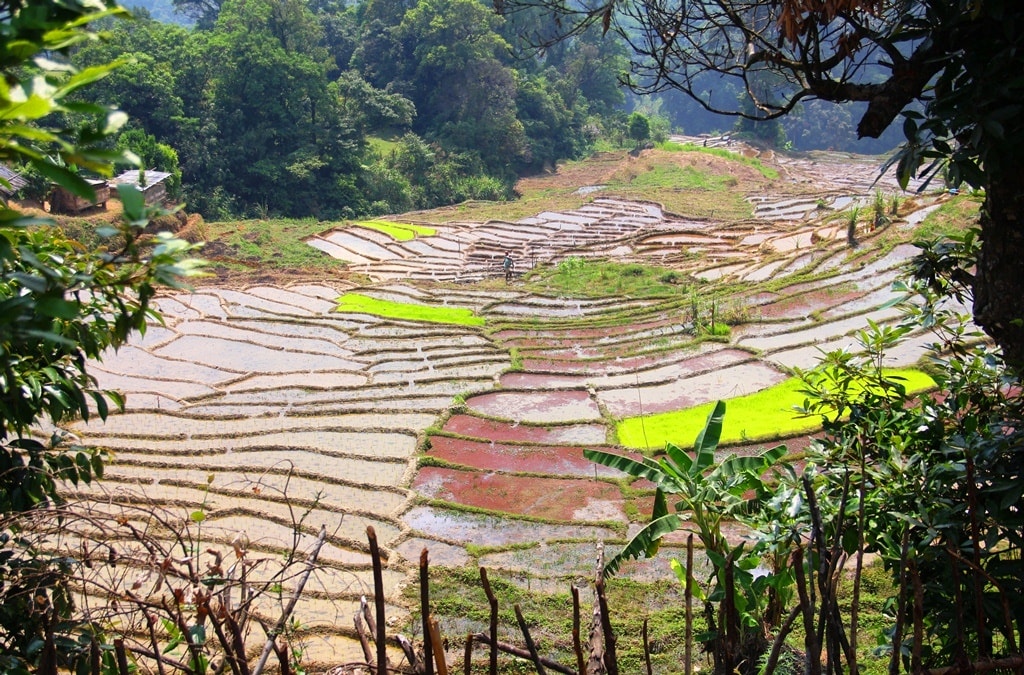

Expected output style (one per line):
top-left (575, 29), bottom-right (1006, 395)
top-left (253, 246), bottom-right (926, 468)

top-left (54, 0), bottom-right (897, 220)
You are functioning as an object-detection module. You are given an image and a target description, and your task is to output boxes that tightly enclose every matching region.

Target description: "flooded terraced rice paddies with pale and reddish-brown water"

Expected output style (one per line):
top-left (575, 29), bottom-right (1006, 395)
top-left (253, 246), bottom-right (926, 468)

top-left (66, 140), bottom-right (958, 663)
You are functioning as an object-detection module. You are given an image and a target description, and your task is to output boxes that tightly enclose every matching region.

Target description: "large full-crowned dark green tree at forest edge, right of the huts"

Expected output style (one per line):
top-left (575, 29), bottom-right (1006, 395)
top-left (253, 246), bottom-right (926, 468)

top-left (210, 0), bottom-right (359, 215)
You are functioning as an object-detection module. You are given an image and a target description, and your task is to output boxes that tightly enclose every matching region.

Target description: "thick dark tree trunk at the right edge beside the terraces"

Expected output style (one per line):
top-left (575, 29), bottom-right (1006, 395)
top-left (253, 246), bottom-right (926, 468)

top-left (974, 167), bottom-right (1024, 370)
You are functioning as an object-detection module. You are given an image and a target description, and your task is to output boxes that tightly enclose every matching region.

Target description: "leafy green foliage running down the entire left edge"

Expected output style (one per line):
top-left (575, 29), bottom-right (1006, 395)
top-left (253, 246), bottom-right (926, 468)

top-left (0, 0), bottom-right (198, 673)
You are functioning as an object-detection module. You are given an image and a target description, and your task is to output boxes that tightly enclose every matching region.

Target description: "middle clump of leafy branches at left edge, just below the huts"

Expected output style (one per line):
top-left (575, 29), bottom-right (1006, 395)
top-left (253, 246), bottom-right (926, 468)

top-left (0, 193), bottom-right (198, 485)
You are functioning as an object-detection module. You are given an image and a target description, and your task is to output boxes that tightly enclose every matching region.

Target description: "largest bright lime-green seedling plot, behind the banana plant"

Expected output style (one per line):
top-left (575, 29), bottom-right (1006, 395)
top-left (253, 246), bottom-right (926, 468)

top-left (616, 370), bottom-right (935, 448)
